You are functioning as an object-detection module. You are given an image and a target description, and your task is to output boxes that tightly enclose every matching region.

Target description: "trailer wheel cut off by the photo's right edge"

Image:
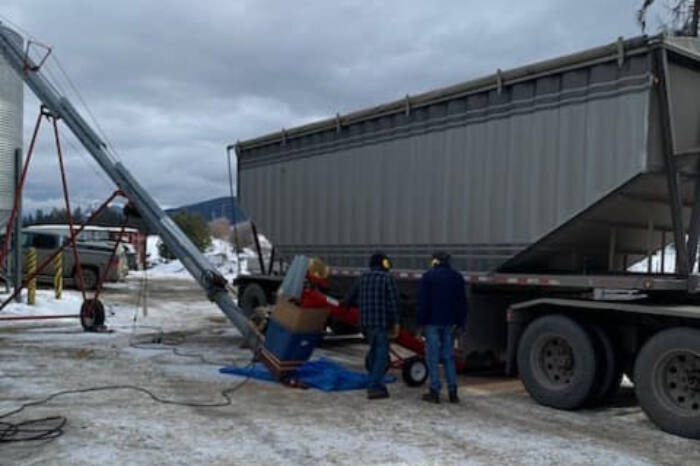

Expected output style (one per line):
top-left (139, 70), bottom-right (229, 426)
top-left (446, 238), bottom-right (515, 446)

top-left (634, 327), bottom-right (700, 439)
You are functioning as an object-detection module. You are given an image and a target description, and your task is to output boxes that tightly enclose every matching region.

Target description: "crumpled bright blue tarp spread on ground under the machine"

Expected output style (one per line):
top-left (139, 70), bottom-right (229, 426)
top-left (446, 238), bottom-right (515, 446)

top-left (219, 358), bottom-right (396, 392)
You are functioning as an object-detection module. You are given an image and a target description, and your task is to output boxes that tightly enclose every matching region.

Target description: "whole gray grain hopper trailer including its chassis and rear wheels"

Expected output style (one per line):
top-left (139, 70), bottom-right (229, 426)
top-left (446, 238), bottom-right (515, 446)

top-left (230, 37), bottom-right (700, 438)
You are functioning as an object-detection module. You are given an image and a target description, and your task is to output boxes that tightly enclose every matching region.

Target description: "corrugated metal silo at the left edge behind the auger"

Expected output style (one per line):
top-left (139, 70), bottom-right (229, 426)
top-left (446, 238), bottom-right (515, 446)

top-left (0, 26), bottom-right (23, 227)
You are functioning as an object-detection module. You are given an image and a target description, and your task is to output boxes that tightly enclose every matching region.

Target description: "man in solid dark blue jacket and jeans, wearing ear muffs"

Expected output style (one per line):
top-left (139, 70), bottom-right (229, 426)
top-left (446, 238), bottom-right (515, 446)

top-left (416, 252), bottom-right (467, 403)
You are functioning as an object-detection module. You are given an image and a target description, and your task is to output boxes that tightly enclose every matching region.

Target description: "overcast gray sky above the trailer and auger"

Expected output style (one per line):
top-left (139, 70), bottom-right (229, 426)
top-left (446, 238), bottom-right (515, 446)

top-left (0, 0), bottom-right (663, 213)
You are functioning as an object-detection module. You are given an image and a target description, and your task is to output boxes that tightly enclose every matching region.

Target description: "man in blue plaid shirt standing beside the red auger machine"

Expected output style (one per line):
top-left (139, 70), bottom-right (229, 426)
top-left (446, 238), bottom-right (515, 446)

top-left (345, 252), bottom-right (399, 400)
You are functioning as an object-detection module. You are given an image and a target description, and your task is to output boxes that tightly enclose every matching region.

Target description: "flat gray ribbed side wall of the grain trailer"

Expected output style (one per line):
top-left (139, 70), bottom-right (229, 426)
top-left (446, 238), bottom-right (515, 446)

top-left (239, 48), bottom-right (651, 271)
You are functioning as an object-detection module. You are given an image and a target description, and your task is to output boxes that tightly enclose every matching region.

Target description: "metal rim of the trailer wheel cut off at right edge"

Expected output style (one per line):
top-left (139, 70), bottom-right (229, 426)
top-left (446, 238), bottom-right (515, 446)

top-left (654, 351), bottom-right (700, 415)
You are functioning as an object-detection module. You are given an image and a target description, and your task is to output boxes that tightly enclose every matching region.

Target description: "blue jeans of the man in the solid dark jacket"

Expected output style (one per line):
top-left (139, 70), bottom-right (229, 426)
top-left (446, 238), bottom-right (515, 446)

top-left (423, 325), bottom-right (457, 392)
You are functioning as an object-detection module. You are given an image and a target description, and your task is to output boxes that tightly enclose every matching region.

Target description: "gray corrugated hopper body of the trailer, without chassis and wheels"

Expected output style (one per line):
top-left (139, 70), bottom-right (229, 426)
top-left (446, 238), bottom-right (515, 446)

top-left (236, 37), bottom-right (700, 273)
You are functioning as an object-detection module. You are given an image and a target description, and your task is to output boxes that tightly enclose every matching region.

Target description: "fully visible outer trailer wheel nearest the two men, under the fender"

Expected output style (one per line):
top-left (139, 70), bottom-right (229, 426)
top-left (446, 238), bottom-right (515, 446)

top-left (518, 315), bottom-right (596, 409)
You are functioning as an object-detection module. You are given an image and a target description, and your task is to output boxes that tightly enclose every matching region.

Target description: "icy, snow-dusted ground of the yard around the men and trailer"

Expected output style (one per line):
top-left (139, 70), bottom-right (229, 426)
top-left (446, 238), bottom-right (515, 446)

top-left (0, 276), bottom-right (700, 466)
